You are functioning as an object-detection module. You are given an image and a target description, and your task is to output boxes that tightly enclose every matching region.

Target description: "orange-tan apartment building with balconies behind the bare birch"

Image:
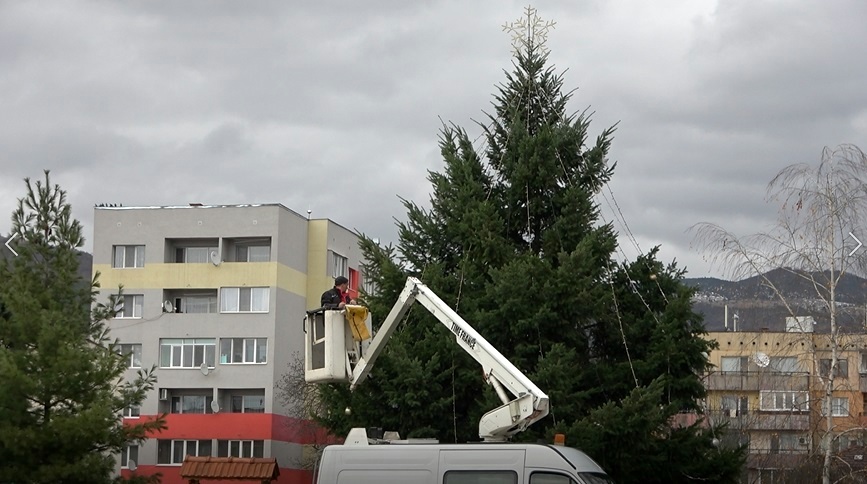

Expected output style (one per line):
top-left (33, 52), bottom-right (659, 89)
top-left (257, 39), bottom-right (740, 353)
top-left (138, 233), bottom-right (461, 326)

top-left (705, 318), bottom-right (867, 482)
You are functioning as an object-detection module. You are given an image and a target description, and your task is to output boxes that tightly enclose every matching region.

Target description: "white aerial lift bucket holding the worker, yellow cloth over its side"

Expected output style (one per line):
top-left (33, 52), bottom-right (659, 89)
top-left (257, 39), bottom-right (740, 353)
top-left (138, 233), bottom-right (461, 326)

top-left (304, 305), bottom-right (371, 383)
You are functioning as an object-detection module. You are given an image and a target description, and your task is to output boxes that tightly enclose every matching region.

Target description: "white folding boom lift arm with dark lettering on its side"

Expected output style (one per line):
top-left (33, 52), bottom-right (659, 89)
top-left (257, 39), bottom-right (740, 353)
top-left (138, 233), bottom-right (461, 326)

top-left (349, 277), bottom-right (549, 441)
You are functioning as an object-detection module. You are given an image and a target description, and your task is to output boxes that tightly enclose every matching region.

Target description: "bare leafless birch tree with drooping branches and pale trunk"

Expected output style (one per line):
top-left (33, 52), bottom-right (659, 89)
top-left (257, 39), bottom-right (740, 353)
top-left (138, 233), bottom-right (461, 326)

top-left (693, 145), bottom-right (867, 484)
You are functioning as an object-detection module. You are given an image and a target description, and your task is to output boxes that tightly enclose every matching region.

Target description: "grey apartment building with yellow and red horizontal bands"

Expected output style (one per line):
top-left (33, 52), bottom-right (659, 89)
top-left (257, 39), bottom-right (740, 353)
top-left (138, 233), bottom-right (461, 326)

top-left (93, 204), bottom-right (363, 484)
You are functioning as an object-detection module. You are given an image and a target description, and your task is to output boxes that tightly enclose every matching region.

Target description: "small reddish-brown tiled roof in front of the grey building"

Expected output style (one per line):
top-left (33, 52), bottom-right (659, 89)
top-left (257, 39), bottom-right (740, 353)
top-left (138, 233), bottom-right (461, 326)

top-left (181, 455), bottom-right (280, 480)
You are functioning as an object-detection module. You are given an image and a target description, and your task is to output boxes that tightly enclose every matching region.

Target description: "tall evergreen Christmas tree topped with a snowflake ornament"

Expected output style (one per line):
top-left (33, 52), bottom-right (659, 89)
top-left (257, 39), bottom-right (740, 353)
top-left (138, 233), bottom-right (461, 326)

top-left (321, 10), bottom-right (743, 483)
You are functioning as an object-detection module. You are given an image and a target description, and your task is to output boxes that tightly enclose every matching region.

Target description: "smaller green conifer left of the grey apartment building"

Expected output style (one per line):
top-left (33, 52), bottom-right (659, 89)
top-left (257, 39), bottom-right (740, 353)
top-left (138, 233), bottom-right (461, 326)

top-left (0, 171), bottom-right (164, 483)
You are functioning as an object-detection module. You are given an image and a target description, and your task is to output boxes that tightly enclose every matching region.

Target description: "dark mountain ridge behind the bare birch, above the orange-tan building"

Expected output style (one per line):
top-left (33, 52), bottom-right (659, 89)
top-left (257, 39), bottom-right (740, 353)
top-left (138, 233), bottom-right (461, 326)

top-left (684, 269), bottom-right (867, 331)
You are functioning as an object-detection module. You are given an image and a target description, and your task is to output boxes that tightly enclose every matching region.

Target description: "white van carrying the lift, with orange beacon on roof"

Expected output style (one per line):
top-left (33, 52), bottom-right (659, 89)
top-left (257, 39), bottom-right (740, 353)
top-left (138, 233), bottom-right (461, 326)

top-left (315, 429), bottom-right (613, 484)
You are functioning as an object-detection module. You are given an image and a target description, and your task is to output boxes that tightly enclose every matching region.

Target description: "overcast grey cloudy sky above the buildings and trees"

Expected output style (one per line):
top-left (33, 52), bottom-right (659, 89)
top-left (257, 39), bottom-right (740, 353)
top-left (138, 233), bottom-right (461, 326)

top-left (0, 0), bottom-right (867, 277)
